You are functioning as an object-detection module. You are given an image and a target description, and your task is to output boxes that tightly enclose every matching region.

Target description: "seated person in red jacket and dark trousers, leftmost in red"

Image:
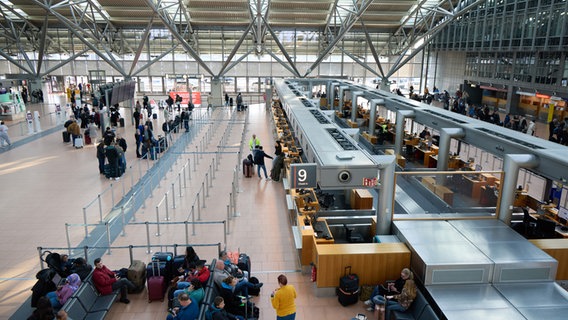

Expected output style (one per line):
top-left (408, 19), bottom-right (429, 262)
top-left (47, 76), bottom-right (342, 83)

top-left (93, 258), bottom-right (136, 304)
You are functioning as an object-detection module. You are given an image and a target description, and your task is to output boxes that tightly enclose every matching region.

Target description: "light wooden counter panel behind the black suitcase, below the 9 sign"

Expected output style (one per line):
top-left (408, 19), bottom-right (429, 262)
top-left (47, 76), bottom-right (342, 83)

top-left (316, 243), bottom-right (410, 288)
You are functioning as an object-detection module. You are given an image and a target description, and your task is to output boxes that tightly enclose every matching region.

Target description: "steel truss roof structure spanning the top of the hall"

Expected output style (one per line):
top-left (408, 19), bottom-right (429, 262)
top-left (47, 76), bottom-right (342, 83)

top-left (0, 0), bottom-right (485, 78)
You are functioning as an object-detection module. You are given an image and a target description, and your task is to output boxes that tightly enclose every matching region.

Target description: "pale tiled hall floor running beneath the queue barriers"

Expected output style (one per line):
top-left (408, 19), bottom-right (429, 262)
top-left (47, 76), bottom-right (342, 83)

top-left (0, 97), bottom-right (556, 320)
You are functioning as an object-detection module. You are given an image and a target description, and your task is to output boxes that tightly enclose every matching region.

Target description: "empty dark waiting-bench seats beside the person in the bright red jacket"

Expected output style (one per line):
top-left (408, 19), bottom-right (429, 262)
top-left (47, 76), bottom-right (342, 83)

top-left (63, 278), bottom-right (118, 320)
